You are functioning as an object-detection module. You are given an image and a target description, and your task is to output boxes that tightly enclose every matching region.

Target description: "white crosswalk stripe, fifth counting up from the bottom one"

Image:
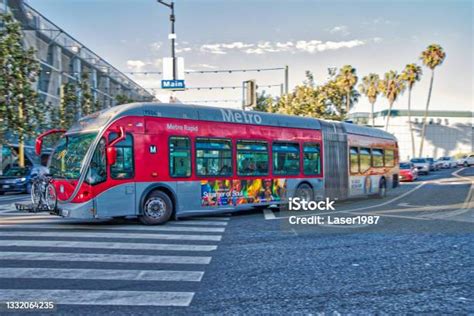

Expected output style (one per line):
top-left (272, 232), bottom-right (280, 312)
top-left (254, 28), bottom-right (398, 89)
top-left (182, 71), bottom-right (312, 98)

top-left (0, 230), bottom-right (222, 241)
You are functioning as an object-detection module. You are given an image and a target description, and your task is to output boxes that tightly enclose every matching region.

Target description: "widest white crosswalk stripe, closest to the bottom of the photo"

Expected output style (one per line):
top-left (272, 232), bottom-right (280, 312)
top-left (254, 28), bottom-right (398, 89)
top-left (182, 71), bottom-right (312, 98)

top-left (0, 289), bottom-right (194, 306)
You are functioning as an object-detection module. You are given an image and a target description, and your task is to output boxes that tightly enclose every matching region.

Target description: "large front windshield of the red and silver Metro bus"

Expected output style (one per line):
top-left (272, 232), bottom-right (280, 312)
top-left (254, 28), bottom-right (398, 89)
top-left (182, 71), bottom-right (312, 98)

top-left (49, 132), bottom-right (97, 179)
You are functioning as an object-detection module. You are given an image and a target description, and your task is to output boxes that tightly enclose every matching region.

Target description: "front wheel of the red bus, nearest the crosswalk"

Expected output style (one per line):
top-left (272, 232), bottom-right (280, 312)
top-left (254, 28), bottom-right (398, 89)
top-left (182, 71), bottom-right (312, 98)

top-left (138, 191), bottom-right (173, 225)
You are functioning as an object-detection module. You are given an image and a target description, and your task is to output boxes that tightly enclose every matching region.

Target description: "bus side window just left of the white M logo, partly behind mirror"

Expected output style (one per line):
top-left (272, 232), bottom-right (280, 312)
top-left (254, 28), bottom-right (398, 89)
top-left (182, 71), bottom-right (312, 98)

top-left (109, 133), bottom-right (134, 179)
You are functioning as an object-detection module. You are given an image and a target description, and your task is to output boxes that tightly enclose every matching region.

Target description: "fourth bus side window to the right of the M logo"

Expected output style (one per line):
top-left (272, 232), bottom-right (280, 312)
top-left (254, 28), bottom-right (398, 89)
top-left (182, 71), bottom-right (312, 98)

top-left (273, 143), bottom-right (300, 175)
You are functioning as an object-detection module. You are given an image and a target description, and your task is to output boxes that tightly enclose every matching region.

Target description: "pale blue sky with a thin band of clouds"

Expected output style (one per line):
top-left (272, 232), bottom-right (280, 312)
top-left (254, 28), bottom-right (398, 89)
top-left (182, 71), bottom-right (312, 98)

top-left (27, 0), bottom-right (474, 112)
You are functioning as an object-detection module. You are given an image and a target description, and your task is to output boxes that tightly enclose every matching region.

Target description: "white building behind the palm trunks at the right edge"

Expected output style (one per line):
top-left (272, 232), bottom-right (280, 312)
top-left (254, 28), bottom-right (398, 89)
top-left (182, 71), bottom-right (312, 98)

top-left (350, 110), bottom-right (474, 160)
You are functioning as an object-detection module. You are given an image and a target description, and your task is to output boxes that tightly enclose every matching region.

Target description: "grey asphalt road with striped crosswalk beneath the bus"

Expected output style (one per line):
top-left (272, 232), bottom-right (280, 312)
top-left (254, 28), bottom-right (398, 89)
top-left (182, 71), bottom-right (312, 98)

top-left (0, 168), bottom-right (474, 315)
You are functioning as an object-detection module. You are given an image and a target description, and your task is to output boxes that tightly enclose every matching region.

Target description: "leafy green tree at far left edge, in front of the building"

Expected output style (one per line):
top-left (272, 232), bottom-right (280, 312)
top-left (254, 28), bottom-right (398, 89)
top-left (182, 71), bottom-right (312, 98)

top-left (0, 14), bottom-right (44, 167)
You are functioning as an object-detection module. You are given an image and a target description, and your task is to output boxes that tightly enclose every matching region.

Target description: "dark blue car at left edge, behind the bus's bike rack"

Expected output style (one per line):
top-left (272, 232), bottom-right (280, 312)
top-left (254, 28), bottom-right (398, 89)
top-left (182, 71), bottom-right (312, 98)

top-left (0, 165), bottom-right (47, 195)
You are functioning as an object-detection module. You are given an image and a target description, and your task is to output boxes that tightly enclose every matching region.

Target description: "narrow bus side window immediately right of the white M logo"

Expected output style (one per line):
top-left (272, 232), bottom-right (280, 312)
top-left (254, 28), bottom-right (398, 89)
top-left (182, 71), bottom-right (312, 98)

top-left (169, 137), bottom-right (191, 177)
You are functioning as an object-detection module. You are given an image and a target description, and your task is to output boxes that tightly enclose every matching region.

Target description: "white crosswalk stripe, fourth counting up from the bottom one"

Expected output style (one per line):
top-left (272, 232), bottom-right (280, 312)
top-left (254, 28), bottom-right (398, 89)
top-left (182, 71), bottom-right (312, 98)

top-left (0, 239), bottom-right (217, 252)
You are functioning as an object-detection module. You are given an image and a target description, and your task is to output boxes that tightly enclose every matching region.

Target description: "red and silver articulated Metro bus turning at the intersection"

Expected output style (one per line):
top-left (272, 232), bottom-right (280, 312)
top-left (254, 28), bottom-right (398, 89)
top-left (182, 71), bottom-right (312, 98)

top-left (36, 103), bottom-right (399, 224)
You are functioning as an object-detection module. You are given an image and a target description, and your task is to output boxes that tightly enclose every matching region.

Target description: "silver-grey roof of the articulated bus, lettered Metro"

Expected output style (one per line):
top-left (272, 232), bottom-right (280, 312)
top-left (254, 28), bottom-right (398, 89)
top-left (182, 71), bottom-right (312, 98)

top-left (67, 102), bottom-right (396, 140)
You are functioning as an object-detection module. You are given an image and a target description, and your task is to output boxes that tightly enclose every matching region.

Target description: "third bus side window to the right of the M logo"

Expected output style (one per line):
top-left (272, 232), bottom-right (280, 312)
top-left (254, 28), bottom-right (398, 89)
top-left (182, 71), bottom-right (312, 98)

top-left (237, 140), bottom-right (268, 176)
